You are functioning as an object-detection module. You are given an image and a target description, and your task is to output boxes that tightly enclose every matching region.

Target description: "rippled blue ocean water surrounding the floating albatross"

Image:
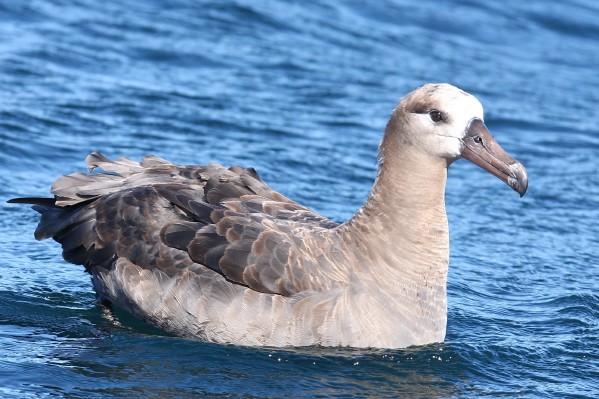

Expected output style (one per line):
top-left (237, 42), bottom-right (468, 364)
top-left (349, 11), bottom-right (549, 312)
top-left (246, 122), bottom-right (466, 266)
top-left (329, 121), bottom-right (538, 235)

top-left (0, 0), bottom-right (599, 398)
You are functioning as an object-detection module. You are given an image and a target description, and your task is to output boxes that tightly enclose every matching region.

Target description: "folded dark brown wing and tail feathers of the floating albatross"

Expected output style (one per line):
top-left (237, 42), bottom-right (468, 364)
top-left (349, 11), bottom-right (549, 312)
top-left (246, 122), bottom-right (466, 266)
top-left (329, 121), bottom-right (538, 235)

top-left (12, 153), bottom-right (337, 295)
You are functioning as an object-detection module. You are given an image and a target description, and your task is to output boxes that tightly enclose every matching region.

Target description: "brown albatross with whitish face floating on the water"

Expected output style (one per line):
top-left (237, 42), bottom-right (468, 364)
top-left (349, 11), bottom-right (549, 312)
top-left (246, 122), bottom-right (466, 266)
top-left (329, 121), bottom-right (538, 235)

top-left (10, 84), bottom-right (528, 348)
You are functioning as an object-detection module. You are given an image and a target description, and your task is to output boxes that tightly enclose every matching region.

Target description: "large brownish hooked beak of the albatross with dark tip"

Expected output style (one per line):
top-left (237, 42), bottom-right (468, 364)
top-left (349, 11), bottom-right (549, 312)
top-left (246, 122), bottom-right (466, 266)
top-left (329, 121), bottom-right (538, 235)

top-left (462, 118), bottom-right (528, 197)
